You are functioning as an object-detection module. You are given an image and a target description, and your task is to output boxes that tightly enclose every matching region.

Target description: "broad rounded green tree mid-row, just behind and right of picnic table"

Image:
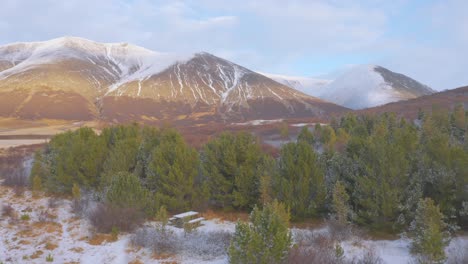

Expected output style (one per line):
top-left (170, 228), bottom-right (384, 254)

top-left (201, 133), bottom-right (268, 208)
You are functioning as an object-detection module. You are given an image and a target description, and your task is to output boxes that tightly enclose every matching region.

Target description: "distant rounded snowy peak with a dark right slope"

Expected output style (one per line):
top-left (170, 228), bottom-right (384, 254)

top-left (319, 65), bottom-right (434, 109)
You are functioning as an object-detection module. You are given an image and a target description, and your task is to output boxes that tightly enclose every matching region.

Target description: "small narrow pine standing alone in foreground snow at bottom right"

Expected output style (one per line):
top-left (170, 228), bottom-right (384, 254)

top-left (410, 198), bottom-right (450, 263)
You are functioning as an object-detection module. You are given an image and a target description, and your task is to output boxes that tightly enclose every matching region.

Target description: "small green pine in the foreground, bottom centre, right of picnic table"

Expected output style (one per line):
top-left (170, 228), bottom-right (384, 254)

top-left (228, 201), bottom-right (292, 264)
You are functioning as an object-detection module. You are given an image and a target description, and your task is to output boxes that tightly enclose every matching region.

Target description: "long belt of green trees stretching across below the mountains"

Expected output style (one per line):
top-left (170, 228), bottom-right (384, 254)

top-left (30, 105), bottom-right (468, 232)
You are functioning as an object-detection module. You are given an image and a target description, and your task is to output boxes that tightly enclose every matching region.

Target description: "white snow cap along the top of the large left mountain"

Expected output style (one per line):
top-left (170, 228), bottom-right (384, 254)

top-left (0, 37), bottom-right (194, 93)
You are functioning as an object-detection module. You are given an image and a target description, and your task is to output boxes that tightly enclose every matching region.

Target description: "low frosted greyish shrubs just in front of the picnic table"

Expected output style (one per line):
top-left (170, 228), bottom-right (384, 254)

top-left (131, 227), bottom-right (231, 259)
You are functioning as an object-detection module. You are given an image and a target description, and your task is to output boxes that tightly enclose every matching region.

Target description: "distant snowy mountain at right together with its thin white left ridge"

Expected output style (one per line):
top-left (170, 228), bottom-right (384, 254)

top-left (264, 65), bottom-right (435, 109)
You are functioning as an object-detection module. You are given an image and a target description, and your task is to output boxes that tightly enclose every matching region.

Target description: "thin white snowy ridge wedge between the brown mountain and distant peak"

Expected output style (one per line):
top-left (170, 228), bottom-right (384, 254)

top-left (259, 72), bottom-right (332, 97)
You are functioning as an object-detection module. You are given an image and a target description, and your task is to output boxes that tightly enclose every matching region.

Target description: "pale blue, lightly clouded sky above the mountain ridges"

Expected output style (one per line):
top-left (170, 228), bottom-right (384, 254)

top-left (0, 0), bottom-right (468, 90)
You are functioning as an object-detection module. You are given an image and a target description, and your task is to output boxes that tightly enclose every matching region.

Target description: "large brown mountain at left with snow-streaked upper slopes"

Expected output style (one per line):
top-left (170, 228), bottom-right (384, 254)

top-left (0, 37), bottom-right (345, 121)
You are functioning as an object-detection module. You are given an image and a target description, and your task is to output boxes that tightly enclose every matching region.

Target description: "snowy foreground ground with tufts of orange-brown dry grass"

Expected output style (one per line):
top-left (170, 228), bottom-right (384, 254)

top-left (0, 186), bottom-right (468, 264)
